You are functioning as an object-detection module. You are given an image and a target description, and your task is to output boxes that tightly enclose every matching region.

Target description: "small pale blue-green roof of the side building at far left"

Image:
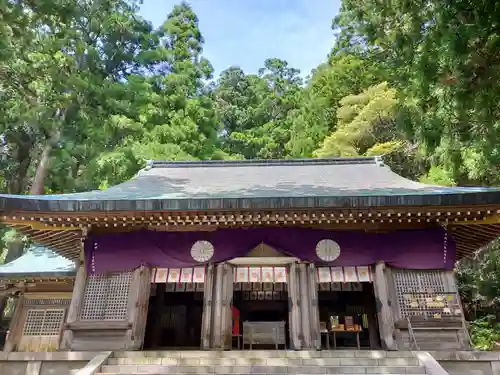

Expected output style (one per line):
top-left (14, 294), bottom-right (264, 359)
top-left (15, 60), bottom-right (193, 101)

top-left (0, 246), bottom-right (76, 278)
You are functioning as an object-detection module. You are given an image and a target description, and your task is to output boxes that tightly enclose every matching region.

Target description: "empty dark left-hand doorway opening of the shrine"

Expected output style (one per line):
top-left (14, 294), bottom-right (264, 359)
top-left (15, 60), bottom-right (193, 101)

top-left (144, 284), bottom-right (203, 349)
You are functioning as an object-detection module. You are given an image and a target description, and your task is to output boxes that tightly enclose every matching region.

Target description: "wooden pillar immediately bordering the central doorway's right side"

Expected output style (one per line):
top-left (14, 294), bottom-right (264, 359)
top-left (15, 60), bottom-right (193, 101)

top-left (288, 263), bottom-right (302, 350)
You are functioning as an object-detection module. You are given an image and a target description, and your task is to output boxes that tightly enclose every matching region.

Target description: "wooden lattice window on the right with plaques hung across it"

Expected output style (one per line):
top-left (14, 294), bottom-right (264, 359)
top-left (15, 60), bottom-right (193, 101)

top-left (393, 270), bottom-right (453, 318)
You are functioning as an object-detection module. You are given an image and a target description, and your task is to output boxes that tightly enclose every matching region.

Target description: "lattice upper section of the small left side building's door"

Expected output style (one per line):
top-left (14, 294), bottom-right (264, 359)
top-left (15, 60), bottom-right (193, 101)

top-left (22, 309), bottom-right (65, 336)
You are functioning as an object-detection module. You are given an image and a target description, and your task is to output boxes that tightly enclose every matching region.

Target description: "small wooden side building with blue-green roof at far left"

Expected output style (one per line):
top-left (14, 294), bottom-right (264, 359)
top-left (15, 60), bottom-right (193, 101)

top-left (0, 245), bottom-right (77, 352)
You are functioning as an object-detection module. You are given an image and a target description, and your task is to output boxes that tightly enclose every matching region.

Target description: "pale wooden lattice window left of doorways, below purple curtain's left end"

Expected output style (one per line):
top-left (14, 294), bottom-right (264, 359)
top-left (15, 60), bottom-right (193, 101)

top-left (80, 272), bottom-right (132, 320)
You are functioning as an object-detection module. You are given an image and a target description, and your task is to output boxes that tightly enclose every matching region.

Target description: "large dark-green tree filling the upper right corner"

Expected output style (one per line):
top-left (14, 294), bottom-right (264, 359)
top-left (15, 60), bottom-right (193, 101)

top-left (334, 0), bottom-right (500, 185)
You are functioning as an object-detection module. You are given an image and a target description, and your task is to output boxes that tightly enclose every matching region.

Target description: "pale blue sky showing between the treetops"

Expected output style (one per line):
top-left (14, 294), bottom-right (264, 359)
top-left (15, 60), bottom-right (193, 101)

top-left (141, 0), bottom-right (340, 76)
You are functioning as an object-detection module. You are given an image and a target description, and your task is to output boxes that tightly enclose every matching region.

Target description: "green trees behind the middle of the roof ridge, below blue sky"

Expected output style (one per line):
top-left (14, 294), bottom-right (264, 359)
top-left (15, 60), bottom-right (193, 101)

top-left (214, 58), bottom-right (302, 159)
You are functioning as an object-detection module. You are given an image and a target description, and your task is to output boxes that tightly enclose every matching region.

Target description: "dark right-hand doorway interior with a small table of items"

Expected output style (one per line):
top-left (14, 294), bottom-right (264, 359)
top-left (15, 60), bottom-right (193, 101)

top-left (318, 283), bottom-right (380, 349)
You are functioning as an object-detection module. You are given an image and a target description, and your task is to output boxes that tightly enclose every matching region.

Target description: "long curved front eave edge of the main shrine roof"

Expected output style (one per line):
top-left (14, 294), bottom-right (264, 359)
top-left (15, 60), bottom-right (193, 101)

top-left (0, 189), bottom-right (500, 213)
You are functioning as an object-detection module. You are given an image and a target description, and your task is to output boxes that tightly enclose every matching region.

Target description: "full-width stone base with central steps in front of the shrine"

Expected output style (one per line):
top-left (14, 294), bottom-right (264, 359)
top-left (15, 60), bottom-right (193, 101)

top-left (0, 350), bottom-right (500, 375)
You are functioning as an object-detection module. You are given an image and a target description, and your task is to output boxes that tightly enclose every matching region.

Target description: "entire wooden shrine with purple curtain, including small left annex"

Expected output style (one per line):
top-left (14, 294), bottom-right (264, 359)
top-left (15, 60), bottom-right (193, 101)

top-left (0, 157), bottom-right (500, 351)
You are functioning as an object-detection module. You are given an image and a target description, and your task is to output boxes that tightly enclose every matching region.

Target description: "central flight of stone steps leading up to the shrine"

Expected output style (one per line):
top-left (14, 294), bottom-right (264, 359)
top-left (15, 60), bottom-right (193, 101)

top-left (98, 350), bottom-right (426, 375)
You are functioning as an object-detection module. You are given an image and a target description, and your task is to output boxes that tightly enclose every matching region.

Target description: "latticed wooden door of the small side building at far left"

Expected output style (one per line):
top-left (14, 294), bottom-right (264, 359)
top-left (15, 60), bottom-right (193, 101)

top-left (18, 308), bottom-right (66, 352)
